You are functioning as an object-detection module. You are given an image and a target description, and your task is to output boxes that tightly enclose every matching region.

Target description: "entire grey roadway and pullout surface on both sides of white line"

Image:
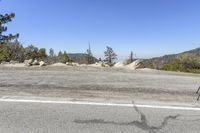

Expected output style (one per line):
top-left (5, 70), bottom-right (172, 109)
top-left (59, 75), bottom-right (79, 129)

top-left (0, 66), bottom-right (200, 133)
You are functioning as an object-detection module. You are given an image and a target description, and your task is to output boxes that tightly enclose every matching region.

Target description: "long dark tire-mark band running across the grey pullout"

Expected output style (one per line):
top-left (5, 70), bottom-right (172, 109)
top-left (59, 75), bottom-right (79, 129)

top-left (0, 83), bottom-right (194, 96)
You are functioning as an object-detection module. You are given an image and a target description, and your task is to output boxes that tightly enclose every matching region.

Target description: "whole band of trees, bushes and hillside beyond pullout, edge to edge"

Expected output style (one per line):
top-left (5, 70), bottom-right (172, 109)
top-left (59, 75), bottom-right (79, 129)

top-left (0, 10), bottom-right (200, 73)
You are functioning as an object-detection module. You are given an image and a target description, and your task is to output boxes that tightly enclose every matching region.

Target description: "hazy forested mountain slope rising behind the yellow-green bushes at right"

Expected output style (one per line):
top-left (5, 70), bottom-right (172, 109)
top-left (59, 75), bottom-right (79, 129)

top-left (144, 48), bottom-right (200, 69)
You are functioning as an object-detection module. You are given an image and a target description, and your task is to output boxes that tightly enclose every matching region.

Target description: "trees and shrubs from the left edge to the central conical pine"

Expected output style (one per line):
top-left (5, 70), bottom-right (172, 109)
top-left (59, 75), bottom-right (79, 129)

top-left (0, 13), bottom-right (117, 66)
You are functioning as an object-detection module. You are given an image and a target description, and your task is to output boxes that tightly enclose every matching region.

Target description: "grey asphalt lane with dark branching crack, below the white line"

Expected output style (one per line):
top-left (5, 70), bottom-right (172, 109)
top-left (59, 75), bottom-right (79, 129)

top-left (0, 102), bottom-right (200, 133)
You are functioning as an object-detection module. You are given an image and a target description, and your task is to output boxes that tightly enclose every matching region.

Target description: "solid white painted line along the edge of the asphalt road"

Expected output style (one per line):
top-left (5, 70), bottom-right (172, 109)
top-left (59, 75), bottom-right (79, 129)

top-left (0, 99), bottom-right (200, 111)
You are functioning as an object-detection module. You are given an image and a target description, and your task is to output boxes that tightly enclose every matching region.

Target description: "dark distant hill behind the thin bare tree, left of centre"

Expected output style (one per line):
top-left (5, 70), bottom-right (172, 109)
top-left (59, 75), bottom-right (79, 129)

top-left (68, 53), bottom-right (97, 64)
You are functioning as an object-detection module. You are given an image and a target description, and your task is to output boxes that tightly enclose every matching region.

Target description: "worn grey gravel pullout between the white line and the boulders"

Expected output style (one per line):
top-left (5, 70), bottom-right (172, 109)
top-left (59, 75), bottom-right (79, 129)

top-left (0, 66), bottom-right (200, 103)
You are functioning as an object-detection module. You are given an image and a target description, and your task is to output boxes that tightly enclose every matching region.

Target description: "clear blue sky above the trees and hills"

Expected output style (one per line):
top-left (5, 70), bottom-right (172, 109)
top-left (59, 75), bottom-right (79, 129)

top-left (0, 0), bottom-right (200, 59)
